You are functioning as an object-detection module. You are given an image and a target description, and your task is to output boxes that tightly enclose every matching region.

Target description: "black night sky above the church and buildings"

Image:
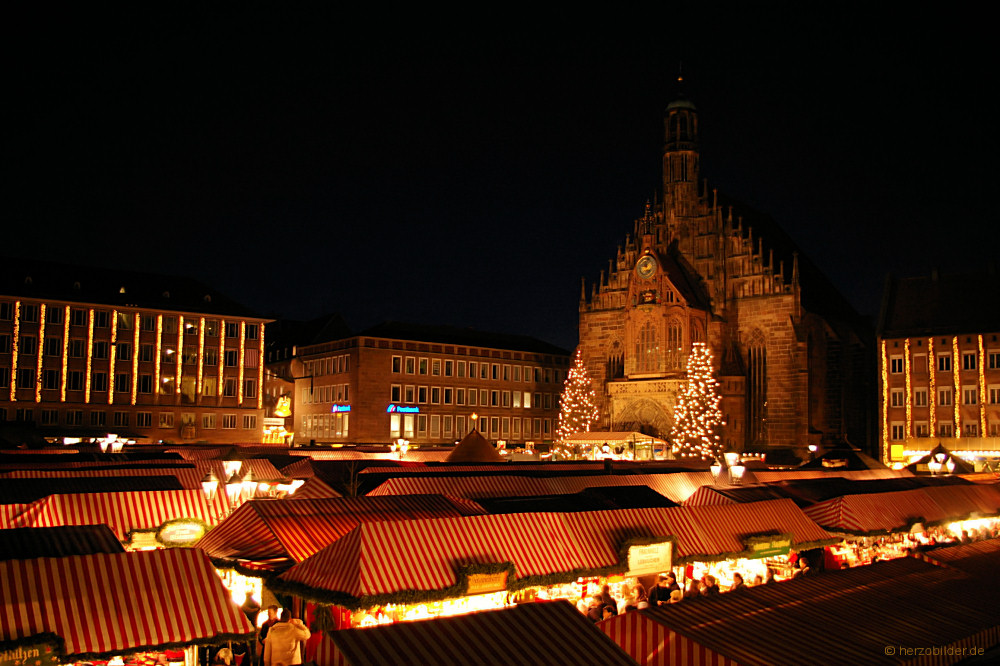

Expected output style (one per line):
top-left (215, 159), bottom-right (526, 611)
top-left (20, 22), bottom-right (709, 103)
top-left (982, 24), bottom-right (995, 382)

top-left (9, 10), bottom-right (1000, 348)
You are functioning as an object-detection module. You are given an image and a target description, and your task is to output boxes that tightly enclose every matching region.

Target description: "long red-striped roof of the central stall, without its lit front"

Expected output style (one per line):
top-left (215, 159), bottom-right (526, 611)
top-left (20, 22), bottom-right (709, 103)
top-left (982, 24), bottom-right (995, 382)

top-left (274, 500), bottom-right (833, 608)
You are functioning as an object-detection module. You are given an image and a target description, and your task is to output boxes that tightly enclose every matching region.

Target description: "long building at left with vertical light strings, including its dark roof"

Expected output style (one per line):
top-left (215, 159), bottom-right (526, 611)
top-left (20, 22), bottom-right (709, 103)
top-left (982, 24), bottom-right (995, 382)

top-left (0, 260), bottom-right (267, 443)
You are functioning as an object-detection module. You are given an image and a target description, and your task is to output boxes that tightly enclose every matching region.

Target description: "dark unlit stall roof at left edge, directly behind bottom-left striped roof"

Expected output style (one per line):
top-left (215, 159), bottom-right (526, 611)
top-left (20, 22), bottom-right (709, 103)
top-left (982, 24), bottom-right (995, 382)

top-left (0, 525), bottom-right (125, 560)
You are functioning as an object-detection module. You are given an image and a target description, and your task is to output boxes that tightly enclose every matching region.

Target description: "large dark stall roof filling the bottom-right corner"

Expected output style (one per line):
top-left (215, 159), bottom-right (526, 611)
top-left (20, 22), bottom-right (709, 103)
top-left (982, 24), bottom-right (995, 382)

top-left (597, 558), bottom-right (1000, 666)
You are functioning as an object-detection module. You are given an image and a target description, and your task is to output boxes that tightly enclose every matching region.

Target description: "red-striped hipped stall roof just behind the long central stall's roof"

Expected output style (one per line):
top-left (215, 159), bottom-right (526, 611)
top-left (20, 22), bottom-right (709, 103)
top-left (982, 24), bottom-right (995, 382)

top-left (198, 495), bottom-right (485, 570)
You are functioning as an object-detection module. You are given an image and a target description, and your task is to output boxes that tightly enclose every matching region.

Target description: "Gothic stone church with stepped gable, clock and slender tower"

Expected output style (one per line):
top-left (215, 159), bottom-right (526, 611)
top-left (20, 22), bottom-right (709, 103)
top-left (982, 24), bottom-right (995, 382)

top-left (579, 94), bottom-right (874, 455)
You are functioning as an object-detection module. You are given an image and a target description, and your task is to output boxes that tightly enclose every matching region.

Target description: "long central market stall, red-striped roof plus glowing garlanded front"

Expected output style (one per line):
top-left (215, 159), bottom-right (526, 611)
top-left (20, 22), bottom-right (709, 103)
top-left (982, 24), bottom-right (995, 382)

top-left (269, 500), bottom-right (833, 626)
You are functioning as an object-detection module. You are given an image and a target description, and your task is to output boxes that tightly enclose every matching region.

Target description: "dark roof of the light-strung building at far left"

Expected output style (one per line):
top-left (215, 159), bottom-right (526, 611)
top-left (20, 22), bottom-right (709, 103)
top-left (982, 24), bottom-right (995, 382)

top-left (0, 257), bottom-right (260, 317)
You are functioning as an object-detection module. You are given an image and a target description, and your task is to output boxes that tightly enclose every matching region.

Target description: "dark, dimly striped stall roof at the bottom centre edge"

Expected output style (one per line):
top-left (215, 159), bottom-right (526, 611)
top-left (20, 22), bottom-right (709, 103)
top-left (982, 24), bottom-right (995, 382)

top-left (316, 601), bottom-right (634, 666)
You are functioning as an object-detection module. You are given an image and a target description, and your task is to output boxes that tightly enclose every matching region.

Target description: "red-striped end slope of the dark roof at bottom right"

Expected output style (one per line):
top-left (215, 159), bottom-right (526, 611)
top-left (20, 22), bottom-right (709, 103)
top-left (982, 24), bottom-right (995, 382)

top-left (597, 612), bottom-right (739, 666)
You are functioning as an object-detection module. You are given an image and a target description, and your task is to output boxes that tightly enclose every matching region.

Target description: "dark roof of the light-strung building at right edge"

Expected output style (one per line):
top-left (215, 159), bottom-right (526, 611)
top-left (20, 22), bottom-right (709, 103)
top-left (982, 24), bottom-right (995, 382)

top-left (878, 270), bottom-right (1000, 338)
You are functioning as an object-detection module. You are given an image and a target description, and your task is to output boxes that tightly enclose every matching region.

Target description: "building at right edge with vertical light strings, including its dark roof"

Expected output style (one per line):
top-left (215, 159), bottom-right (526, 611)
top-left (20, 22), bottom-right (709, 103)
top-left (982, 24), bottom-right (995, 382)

top-left (878, 272), bottom-right (1000, 463)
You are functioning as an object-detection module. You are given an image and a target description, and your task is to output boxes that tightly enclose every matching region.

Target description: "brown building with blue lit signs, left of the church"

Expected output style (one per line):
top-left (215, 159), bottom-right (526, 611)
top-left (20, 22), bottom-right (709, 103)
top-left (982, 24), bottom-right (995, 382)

top-left (293, 323), bottom-right (569, 446)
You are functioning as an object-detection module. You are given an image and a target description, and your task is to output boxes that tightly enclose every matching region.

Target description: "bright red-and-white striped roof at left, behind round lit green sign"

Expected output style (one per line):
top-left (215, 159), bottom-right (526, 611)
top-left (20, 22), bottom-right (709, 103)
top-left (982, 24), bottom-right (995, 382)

top-left (11, 490), bottom-right (226, 541)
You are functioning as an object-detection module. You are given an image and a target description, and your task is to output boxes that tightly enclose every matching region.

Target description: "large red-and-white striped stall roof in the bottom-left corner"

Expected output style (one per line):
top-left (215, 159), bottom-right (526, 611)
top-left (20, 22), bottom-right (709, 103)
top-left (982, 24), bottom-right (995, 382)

top-left (0, 548), bottom-right (253, 659)
